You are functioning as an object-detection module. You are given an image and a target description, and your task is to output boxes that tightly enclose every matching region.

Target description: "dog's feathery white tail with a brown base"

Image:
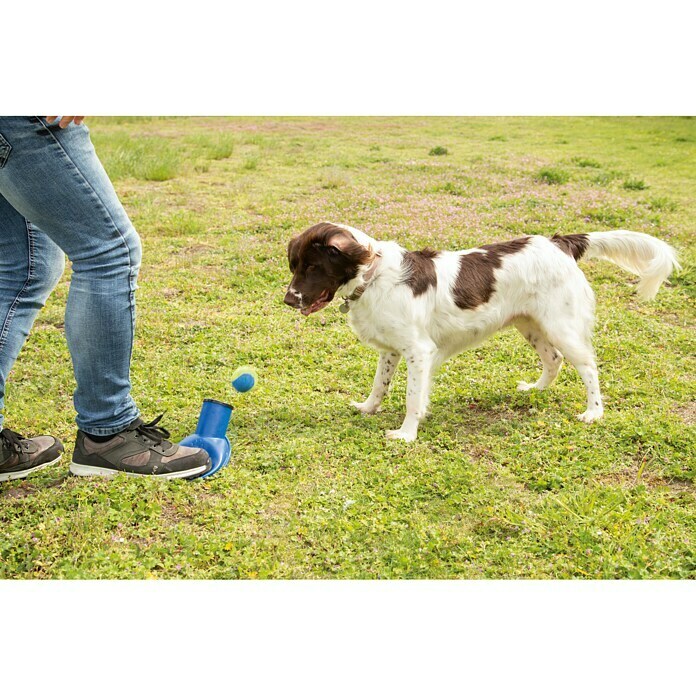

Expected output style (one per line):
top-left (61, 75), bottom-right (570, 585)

top-left (553, 230), bottom-right (681, 300)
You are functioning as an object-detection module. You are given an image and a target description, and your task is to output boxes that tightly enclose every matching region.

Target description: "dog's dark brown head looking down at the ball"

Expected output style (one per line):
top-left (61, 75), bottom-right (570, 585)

top-left (285, 222), bottom-right (373, 316)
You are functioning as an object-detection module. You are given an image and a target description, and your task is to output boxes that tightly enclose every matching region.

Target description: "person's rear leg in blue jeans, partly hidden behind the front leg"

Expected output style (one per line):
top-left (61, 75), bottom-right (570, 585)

top-left (0, 195), bottom-right (65, 429)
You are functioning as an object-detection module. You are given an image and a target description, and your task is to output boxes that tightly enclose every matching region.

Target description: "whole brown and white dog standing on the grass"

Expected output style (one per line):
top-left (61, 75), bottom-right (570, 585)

top-left (285, 222), bottom-right (680, 442)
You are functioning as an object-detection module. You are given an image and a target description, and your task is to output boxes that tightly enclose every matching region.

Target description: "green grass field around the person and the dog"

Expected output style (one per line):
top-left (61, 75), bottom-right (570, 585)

top-left (0, 118), bottom-right (696, 578)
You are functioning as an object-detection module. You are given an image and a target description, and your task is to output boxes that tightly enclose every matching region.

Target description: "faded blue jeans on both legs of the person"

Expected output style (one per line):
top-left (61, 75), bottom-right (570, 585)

top-left (0, 116), bottom-right (141, 435)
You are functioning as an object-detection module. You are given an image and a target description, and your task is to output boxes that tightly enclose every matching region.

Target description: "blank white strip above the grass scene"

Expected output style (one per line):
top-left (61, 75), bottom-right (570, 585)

top-left (5, 0), bottom-right (696, 115)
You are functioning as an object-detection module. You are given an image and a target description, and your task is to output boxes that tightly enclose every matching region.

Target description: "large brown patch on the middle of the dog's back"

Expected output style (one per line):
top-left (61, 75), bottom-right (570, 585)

top-left (452, 237), bottom-right (530, 309)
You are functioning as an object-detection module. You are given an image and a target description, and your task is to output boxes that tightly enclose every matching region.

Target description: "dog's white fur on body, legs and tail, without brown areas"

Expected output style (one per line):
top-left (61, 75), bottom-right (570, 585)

top-left (330, 225), bottom-right (679, 441)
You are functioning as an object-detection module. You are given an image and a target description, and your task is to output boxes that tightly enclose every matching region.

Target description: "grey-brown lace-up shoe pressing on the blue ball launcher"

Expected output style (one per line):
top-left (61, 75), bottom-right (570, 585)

top-left (70, 415), bottom-right (212, 479)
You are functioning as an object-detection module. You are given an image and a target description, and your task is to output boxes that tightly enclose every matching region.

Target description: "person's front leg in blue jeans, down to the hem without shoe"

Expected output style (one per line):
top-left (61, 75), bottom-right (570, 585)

top-left (0, 117), bottom-right (141, 436)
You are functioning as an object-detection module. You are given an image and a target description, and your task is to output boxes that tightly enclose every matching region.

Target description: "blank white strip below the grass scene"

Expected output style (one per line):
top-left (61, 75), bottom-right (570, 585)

top-left (0, 581), bottom-right (696, 696)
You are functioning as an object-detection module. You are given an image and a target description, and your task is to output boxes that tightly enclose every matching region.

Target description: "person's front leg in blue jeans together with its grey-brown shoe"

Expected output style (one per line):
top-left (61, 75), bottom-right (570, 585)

top-left (0, 116), bottom-right (211, 480)
